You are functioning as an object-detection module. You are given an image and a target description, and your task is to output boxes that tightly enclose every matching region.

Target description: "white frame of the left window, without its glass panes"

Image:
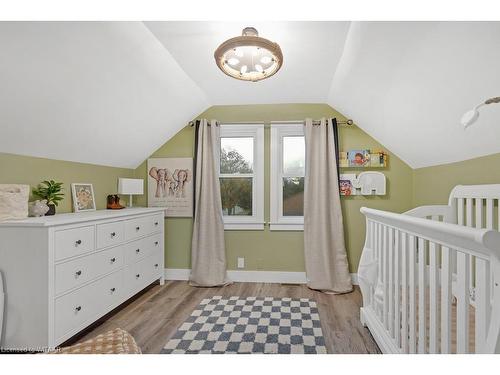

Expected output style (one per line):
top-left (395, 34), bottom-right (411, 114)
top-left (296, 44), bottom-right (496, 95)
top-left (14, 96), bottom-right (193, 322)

top-left (216, 124), bottom-right (264, 230)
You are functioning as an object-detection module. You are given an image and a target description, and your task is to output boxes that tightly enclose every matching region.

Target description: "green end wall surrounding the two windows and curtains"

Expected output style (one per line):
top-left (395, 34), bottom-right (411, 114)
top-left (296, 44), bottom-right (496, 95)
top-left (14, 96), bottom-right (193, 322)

top-left (135, 104), bottom-right (413, 272)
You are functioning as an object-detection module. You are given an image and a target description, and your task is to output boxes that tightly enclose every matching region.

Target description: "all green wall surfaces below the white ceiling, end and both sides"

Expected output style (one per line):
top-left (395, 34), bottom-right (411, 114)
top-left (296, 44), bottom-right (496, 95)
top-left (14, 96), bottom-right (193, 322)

top-left (0, 104), bottom-right (500, 272)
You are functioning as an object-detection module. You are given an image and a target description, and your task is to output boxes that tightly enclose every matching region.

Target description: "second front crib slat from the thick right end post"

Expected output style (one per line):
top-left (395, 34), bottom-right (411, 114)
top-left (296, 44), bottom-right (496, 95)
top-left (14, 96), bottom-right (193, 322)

top-left (441, 246), bottom-right (452, 354)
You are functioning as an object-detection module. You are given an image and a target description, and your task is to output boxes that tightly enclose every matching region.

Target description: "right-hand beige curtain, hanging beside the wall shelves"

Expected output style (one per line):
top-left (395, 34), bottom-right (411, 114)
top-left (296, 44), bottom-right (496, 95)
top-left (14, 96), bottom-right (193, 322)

top-left (304, 119), bottom-right (352, 293)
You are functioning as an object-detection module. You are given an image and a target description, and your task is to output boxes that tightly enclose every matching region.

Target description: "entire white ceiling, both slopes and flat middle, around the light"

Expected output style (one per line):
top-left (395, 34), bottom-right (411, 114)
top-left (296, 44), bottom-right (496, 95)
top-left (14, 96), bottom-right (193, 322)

top-left (0, 21), bottom-right (500, 168)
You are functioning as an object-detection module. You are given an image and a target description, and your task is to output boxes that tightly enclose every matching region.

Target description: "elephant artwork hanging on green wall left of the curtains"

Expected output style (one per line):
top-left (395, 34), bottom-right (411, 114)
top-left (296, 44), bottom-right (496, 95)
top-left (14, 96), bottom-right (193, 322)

top-left (148, 158), bottom-right (193, 217)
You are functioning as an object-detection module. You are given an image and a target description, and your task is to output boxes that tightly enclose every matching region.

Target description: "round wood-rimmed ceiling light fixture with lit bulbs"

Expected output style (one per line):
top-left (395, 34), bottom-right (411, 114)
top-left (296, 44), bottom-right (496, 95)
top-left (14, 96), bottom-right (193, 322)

top-left (214, 27), bottom-right (283, 82)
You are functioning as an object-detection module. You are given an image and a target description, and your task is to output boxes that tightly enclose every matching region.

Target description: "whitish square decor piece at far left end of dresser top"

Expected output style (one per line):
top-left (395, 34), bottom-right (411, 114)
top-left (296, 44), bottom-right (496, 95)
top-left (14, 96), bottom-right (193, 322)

top-left (0, 184), bottom-right (30, 221)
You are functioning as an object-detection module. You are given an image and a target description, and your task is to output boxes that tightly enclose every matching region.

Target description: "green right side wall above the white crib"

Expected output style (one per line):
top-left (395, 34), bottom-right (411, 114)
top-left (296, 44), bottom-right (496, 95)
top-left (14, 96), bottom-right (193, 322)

top-left (413, 154), bottom-right (500, 206)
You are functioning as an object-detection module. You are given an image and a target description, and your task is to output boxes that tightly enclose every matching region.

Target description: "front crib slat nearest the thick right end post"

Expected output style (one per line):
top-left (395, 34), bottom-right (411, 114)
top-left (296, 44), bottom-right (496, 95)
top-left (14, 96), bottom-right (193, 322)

top-left (456, 252), bottom-right (470, 354)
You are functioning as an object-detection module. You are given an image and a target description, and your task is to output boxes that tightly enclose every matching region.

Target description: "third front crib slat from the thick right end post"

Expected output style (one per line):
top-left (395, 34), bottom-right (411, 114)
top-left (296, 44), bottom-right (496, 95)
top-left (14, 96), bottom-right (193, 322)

top-left (429, 242), bottom-right (439, 354)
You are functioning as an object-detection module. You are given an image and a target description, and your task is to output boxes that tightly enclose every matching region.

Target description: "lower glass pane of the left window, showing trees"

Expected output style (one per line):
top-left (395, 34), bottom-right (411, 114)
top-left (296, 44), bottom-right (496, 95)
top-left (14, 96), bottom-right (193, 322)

top-left (220, 177), bottom-right (252, 216)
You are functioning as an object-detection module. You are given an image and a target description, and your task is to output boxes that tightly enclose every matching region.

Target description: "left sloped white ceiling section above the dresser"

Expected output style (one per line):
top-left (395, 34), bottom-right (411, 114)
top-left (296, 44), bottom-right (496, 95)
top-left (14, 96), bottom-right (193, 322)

top-left (0, 22), bottom-right (209, 168)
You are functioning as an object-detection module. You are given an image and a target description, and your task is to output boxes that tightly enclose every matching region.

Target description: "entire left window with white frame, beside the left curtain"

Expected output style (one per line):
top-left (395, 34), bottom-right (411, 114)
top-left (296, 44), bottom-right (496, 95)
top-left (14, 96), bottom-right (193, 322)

top-left (218, 124), bottom-right (264, 230)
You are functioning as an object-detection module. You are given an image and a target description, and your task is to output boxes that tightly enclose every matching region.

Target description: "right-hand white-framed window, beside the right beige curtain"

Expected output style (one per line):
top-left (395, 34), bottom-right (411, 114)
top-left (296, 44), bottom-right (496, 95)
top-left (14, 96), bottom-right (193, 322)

top-left (271, 124), bottom-right (306, 230)
